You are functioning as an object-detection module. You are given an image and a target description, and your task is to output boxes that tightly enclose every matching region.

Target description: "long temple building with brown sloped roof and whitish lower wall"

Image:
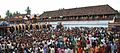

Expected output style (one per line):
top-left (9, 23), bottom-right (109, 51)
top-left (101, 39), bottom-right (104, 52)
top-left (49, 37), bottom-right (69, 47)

top-left (40, 5), bottom-right (119, 27)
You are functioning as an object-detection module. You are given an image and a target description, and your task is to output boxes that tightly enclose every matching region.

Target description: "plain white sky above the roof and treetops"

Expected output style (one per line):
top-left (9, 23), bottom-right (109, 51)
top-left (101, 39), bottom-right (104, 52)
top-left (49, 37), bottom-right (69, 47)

top-left (0, 0), bottom-right (120, 17)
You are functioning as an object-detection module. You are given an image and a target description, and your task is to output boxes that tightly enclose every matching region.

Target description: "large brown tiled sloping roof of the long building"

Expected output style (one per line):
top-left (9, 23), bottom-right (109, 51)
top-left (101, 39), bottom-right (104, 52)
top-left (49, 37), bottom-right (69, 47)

top-left (40, 5), bottom-right (118, 18)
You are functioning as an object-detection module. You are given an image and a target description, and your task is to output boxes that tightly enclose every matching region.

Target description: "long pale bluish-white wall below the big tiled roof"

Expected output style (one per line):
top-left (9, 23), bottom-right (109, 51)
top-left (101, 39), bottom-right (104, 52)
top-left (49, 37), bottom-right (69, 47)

top-left (40, 20), bottom-right (113, 27)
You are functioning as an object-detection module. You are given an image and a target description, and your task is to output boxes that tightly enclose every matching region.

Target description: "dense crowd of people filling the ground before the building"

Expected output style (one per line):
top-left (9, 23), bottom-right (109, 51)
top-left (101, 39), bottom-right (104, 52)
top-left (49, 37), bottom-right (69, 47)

top-left (0, 25), bottom-right (120, 53)
